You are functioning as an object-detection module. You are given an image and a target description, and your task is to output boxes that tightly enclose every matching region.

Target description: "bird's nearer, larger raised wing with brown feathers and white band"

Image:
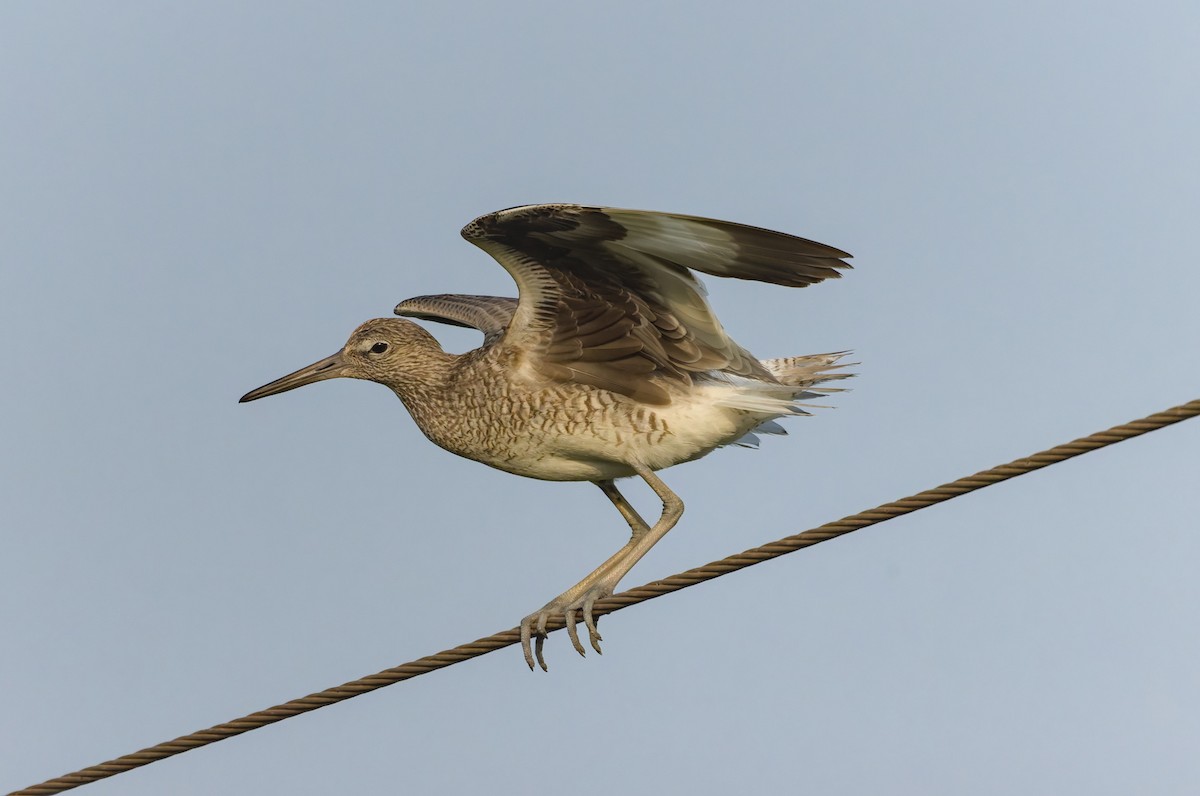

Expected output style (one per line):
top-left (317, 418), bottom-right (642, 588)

top-left (462, 204), bottom-right (850, 403)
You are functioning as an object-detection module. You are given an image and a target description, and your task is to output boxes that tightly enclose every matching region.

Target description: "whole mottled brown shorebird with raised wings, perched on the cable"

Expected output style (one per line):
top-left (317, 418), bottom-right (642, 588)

top-left (241, 204), bottom-right (850, 670)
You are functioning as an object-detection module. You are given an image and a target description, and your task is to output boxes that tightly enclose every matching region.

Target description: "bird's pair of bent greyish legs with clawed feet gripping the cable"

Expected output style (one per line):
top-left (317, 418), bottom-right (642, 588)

top-left (521, 465), bottom-right (683, 671)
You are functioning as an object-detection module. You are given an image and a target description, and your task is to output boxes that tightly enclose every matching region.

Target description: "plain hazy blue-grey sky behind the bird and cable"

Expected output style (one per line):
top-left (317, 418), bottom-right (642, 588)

top-left (0, 0), bottom-right (1200, 796)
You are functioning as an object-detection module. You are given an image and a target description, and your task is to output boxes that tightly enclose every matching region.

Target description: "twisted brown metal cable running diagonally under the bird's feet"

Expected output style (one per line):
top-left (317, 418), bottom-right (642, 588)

top-left (8, 399), bottom-right (1200, 796)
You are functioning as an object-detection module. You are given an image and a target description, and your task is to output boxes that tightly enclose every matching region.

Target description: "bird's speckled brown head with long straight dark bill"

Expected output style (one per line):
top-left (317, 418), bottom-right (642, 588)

top-left (239, 318), bottom-right (445, 403)
